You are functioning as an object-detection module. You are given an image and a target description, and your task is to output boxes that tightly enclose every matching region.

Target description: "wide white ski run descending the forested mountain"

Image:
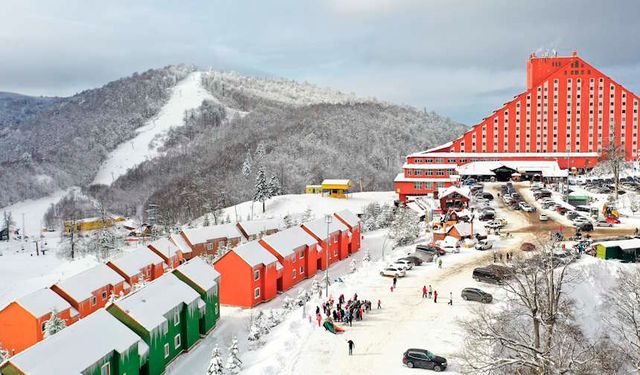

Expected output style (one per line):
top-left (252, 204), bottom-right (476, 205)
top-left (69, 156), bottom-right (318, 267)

top-left (93, 72), bottom-right (214, 185)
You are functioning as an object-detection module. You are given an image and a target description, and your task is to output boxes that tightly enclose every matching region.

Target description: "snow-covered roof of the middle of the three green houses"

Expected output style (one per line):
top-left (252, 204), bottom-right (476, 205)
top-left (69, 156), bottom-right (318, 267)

top-left (114, 273), bottom-right (200, 331)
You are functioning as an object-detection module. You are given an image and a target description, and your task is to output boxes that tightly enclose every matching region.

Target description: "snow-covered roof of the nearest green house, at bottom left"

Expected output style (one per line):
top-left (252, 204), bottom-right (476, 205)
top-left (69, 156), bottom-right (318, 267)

top-left (9, 310), bottom-right (143, 375)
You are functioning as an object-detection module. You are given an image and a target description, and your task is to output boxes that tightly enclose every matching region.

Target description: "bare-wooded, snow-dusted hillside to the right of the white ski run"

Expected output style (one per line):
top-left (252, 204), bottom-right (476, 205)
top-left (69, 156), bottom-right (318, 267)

top-left (100, 71), bottom-right (466, 222)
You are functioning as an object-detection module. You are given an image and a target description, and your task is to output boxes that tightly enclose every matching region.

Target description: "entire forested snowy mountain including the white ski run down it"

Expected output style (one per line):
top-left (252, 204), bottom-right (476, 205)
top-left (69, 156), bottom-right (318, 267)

top-left (0, 66), bottom-right (465, 225)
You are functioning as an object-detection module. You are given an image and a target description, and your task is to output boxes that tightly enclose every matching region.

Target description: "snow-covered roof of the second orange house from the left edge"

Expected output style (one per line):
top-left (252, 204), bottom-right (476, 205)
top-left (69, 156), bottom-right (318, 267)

top-left (56, 264), bottom-right (125, 302)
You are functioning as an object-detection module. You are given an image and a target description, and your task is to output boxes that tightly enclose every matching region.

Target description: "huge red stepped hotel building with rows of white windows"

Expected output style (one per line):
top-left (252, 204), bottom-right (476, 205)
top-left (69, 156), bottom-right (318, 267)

top-left (395, 52), bottom-right (638, 202)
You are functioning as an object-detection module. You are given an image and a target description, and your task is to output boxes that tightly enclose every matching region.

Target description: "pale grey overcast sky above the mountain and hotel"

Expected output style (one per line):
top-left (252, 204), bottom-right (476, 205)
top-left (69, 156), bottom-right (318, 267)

top-left (0, 0), bottom-right (640, 124)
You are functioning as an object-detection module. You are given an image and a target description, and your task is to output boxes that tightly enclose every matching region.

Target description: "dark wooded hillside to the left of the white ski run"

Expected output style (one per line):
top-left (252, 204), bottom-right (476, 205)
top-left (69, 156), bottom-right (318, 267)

top-left (0, 66), bottom-right (194, 207)
